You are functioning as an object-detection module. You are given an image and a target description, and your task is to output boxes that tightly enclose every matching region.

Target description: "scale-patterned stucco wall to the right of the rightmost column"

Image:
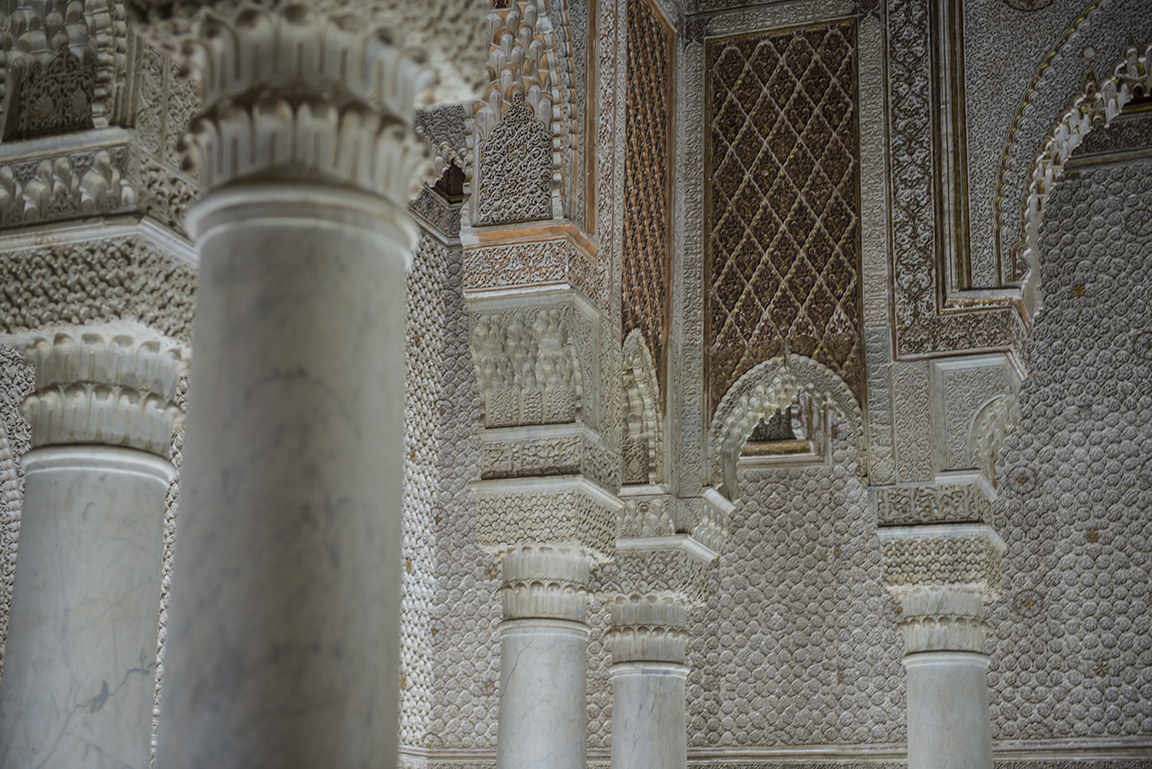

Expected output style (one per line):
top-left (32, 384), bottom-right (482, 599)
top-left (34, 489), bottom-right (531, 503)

top-left (990, 165), bottom-right (1152, 739)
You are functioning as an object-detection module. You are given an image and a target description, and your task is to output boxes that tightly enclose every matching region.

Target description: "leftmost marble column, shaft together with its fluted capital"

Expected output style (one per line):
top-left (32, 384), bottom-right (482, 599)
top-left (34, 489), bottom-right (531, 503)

top-left (0, 328), bottom-right (187, 769)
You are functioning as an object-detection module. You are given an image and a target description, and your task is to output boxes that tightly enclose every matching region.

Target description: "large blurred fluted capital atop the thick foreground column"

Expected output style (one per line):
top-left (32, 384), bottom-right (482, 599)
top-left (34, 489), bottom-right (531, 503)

top-left (134, 0), bottom-right (488, 205)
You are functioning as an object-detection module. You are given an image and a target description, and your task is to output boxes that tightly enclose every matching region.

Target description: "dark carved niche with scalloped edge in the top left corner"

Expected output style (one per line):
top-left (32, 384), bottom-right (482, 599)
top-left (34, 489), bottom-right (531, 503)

top-left (0, 0), bottom-right (128, 139)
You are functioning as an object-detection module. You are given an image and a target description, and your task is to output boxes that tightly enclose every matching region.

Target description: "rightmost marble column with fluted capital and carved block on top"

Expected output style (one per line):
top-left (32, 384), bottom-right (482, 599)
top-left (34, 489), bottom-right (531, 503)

top-left (880, 524), bottom-right (1005, 769)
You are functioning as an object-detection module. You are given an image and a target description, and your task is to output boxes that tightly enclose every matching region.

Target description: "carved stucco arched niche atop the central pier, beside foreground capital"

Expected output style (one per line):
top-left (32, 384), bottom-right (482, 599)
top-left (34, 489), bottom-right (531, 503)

top-left (464, 0), bottom-right (575, 224)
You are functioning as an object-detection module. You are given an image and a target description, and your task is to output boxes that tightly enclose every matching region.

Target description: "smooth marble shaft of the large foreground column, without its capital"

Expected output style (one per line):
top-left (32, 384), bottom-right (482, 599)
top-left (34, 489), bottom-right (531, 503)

top-left (158, 183), bottom-right (416, 769)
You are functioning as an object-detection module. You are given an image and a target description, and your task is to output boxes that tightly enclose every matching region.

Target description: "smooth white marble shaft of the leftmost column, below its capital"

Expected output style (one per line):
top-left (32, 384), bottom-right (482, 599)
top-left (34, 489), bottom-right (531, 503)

top-left (0, 446), bottom-right (174, 769)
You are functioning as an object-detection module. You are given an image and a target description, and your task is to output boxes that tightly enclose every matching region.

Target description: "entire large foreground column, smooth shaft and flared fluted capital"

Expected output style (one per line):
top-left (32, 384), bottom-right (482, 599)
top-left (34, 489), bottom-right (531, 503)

top-left (124, 0), bottom-right (487, 769)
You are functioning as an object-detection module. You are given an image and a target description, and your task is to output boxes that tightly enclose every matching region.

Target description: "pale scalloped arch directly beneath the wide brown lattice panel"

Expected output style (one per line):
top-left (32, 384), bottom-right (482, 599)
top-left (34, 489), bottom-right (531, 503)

top-left (707, 353), bottom-right (867, 501)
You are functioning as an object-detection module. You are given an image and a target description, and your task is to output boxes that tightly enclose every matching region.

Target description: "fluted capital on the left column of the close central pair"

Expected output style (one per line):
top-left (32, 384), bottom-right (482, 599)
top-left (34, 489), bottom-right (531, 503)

top-left (498, 545), bottom-right (596, 622)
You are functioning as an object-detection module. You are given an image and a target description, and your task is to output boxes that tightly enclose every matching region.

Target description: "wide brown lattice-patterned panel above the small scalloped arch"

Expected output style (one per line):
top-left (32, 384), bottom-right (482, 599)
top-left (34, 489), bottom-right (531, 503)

top-left (705, 21), bottom-right (864, 413)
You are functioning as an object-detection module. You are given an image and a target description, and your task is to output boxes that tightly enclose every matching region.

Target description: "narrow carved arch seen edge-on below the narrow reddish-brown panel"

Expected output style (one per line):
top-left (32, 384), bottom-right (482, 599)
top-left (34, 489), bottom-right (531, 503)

top-left (621, 329), bottom-right (664, 485)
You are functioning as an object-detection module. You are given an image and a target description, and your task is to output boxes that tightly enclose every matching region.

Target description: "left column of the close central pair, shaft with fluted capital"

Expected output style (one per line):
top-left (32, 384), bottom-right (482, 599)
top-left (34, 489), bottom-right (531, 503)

top-left (497, 546), bottom-right (592, 769)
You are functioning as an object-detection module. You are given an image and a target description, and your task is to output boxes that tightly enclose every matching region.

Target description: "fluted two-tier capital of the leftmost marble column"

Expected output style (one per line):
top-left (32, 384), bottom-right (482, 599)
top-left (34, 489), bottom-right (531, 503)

top-left (21, 327), bottom-right (188, 458)
